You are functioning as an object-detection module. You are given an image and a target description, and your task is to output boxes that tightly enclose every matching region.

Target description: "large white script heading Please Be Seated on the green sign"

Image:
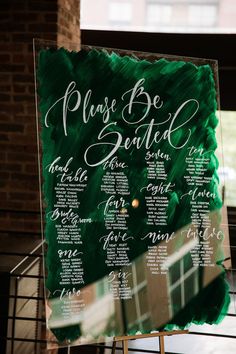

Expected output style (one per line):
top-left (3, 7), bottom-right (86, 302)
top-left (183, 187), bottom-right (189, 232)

top-left (44, 78), bottom-right (199, 167)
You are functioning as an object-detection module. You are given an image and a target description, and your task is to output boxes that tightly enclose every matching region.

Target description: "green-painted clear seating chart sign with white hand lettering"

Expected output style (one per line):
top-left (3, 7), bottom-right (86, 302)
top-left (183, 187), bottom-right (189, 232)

top-left (34, 43), bottom-right (229, 346)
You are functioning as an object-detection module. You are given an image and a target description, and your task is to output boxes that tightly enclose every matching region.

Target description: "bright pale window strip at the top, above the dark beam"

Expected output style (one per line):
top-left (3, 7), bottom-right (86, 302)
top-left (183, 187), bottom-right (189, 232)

top-left (81, 0), bottom-right (236, 33)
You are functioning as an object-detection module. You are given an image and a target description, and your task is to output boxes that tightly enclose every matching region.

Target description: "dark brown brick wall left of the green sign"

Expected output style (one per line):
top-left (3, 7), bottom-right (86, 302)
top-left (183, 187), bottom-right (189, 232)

top-left (0, 0), bottom-right (80, 253)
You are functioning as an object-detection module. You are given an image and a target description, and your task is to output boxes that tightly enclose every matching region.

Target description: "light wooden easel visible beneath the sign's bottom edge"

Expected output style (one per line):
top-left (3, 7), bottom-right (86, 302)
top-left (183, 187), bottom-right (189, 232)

top-left (111, 330), bottom-right (188, 354)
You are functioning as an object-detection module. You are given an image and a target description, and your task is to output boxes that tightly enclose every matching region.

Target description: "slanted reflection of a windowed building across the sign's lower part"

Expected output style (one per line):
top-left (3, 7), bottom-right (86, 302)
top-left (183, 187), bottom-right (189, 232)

top-left (45, 218), bottom-right (229, 347)
